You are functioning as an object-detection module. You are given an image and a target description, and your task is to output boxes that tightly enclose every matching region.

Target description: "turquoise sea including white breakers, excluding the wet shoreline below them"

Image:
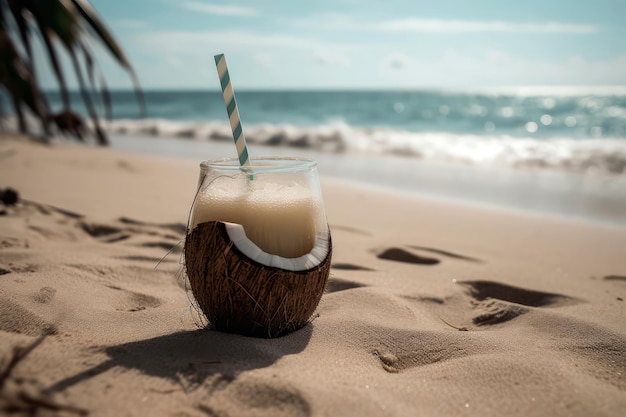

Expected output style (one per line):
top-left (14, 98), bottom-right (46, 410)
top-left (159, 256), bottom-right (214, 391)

top-left (37, 88), bottom-right (626, 175)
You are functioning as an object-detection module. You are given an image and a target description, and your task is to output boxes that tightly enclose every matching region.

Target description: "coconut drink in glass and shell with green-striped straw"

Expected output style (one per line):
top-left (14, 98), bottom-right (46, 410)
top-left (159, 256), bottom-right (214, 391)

top-left (184, 55), bottom-right (332, 337)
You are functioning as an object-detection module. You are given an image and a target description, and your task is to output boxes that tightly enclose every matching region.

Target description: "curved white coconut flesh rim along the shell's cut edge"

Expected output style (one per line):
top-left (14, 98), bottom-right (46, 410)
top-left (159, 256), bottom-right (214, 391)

top-left (224, 222), bottom-right (329, 271)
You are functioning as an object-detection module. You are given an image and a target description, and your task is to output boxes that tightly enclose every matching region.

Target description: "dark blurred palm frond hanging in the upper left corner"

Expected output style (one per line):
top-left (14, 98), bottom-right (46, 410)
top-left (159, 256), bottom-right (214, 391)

top-left (0, 0), bottom-right (146, 144)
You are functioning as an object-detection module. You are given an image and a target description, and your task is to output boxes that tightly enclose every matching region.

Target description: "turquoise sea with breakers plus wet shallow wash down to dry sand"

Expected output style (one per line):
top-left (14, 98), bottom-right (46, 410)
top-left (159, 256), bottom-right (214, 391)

top-left (1, 87), bottom-right (626, 225)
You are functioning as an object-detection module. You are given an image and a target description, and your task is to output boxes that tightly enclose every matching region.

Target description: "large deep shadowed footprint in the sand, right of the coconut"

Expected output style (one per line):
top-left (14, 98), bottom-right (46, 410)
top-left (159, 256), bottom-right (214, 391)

top-left (459, 281), bottom-right (581, 326)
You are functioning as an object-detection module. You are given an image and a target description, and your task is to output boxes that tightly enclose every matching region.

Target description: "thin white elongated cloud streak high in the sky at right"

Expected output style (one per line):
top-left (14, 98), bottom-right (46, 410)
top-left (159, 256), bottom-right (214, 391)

top-left (371, 18), bottom-right (597, 34)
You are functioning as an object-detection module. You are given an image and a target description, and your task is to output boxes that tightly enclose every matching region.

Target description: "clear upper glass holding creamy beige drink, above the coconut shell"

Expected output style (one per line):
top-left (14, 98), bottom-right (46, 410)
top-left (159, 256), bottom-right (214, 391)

top-left (191, 157), bottom-right (328, 258)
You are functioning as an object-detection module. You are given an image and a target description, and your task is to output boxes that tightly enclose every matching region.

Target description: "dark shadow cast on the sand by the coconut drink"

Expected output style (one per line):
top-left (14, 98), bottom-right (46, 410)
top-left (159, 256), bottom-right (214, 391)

top-left (45, 323), bottom-right (312, 393)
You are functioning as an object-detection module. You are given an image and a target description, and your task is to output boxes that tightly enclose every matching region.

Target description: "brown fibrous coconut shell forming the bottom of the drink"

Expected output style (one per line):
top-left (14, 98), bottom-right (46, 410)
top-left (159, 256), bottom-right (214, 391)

top-left (184, 221), bottom-right (332, 338)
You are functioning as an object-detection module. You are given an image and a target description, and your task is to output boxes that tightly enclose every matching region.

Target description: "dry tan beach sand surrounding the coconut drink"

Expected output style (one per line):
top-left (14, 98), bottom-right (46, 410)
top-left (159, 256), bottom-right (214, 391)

top-left (0, 137), bottom-right (626, 416)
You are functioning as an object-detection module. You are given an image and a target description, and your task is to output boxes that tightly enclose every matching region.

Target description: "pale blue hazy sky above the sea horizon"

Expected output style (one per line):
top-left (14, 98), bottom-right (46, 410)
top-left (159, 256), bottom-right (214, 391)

top-left (44, 0), bottom-right (626, 90)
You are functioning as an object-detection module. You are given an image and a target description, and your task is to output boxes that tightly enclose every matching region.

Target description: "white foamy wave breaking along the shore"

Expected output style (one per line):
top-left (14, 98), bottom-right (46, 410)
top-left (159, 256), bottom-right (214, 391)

top-left (108, 119), bottom-right (626, 175)
